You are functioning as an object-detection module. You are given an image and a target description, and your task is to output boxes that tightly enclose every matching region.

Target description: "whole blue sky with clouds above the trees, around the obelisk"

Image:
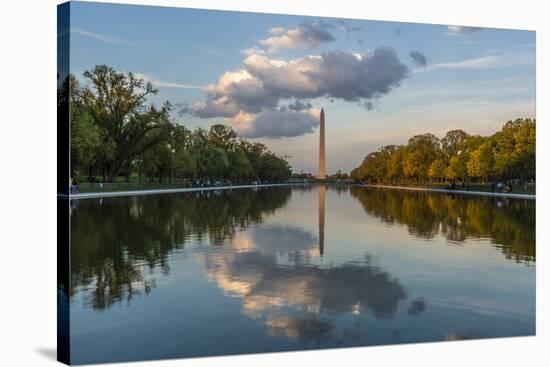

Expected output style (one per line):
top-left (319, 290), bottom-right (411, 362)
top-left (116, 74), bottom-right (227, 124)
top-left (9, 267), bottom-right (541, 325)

top-left (67, 2), bottom-right (536, 173)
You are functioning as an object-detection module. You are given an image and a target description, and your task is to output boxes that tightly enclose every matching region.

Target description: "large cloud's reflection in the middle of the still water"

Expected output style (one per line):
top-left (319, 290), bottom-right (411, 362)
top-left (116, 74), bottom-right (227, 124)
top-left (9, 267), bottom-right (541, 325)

top-left (205, 226), bottom-right (407, 340)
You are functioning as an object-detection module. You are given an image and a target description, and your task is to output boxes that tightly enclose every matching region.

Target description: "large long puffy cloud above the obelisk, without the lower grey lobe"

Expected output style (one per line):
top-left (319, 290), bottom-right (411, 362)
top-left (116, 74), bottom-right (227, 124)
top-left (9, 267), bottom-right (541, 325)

top-left (195, 48), bottom-right (408, 117)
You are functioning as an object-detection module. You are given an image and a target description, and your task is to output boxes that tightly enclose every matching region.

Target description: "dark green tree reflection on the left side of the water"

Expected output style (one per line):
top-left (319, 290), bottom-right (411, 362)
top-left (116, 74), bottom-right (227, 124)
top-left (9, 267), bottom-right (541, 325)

top-left (70, 188), bottom-right (291, 309)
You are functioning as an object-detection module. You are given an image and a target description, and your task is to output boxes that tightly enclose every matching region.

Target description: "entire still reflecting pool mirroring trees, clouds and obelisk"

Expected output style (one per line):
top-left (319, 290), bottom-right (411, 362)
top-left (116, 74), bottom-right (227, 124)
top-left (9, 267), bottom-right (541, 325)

top-left (69, 186), bottom-right (536, 364)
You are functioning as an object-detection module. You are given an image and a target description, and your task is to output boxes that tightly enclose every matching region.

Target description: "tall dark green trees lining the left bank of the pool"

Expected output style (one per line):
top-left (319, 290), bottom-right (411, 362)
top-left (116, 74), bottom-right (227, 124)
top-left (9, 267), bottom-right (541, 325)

top-left (66, 65), bottom-right (291, 182)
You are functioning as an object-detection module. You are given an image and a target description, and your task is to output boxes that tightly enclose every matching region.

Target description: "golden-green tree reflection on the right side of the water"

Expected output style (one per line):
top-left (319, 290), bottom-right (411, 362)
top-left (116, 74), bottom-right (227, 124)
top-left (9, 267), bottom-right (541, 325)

top-left (350, 187), bottom-right (536, 264)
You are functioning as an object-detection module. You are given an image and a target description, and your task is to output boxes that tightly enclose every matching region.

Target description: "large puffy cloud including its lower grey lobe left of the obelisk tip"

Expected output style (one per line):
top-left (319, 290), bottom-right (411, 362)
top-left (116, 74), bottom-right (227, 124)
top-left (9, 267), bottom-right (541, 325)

top-left (186, 48), bottom-right (408, 137)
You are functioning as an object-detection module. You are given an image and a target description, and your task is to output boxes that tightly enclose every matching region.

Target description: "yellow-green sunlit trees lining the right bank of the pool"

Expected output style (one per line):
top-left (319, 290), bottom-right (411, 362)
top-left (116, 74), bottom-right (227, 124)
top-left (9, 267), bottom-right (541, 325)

top-left (351, 119), bottom-right (536, 184)
